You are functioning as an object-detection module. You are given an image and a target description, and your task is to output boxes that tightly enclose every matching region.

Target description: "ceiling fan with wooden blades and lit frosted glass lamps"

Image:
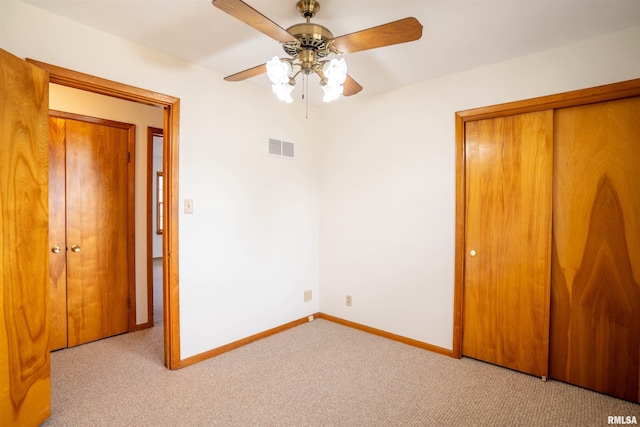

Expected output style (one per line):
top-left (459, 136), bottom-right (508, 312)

top-left (212, 0), bottom-right (422, 102)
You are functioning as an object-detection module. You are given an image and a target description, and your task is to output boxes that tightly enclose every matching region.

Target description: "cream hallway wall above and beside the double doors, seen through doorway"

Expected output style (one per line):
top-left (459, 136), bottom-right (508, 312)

top-left (49, 84), bottom-right (164, 325)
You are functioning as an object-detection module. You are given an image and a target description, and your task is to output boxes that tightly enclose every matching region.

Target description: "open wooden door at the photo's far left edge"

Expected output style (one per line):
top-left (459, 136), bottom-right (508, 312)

top-left (0, 49), bottom-right (50, 426)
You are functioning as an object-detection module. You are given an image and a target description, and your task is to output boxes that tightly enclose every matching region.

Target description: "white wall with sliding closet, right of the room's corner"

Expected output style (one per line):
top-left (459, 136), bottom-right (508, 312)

top-left (320, 27), bottom-right (640, 349)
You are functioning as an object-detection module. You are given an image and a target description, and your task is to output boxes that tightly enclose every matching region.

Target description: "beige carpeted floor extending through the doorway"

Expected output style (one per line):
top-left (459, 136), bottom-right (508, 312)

top-left (43, 320), bottom-right (640, 427)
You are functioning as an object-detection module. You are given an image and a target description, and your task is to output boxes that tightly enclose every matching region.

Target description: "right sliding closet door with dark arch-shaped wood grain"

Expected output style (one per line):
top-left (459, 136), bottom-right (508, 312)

top-left (550, 97), bottom-right (640, 402)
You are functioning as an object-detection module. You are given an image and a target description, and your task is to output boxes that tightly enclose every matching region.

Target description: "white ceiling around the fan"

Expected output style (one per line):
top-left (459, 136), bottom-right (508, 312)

top-left (23, 0), bottom-right (640, 106)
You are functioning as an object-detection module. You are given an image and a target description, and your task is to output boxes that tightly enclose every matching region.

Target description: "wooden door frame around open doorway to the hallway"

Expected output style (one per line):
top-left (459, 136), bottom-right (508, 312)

top-left (26, 58), bottom-right (181, 370)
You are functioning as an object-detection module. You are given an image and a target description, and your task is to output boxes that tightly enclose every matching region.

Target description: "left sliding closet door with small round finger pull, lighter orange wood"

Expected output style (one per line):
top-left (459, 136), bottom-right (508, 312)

top-left (462, 111), bottom-right (553, 377)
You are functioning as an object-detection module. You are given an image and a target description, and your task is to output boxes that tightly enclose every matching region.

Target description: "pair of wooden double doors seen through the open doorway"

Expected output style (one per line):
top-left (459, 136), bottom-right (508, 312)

top-left (49, 117), bottom-right (130, 350)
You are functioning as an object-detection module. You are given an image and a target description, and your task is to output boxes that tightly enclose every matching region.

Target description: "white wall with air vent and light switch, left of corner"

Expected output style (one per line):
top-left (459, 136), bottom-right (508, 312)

top-left (0, 0), bottom-right (320, 358)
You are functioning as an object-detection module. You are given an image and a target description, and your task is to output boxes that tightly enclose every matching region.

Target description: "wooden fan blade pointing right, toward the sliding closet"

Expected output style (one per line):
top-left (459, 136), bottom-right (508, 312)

top-left (333, 18), bottom-right (422, 53)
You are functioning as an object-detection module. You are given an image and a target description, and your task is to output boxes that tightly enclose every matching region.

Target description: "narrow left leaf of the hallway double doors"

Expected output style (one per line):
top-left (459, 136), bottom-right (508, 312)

top-left (49, 117), bottom-right (67, 351)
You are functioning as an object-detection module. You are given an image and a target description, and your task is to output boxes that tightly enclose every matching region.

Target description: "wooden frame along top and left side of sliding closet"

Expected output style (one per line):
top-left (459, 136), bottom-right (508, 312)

top-left (452, 79), bottom-right (640, 359)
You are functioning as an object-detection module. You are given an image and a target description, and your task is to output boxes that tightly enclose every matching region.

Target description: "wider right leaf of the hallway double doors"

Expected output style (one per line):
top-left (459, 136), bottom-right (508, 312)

top-left (66, 120), bottom-right (129, 347)
